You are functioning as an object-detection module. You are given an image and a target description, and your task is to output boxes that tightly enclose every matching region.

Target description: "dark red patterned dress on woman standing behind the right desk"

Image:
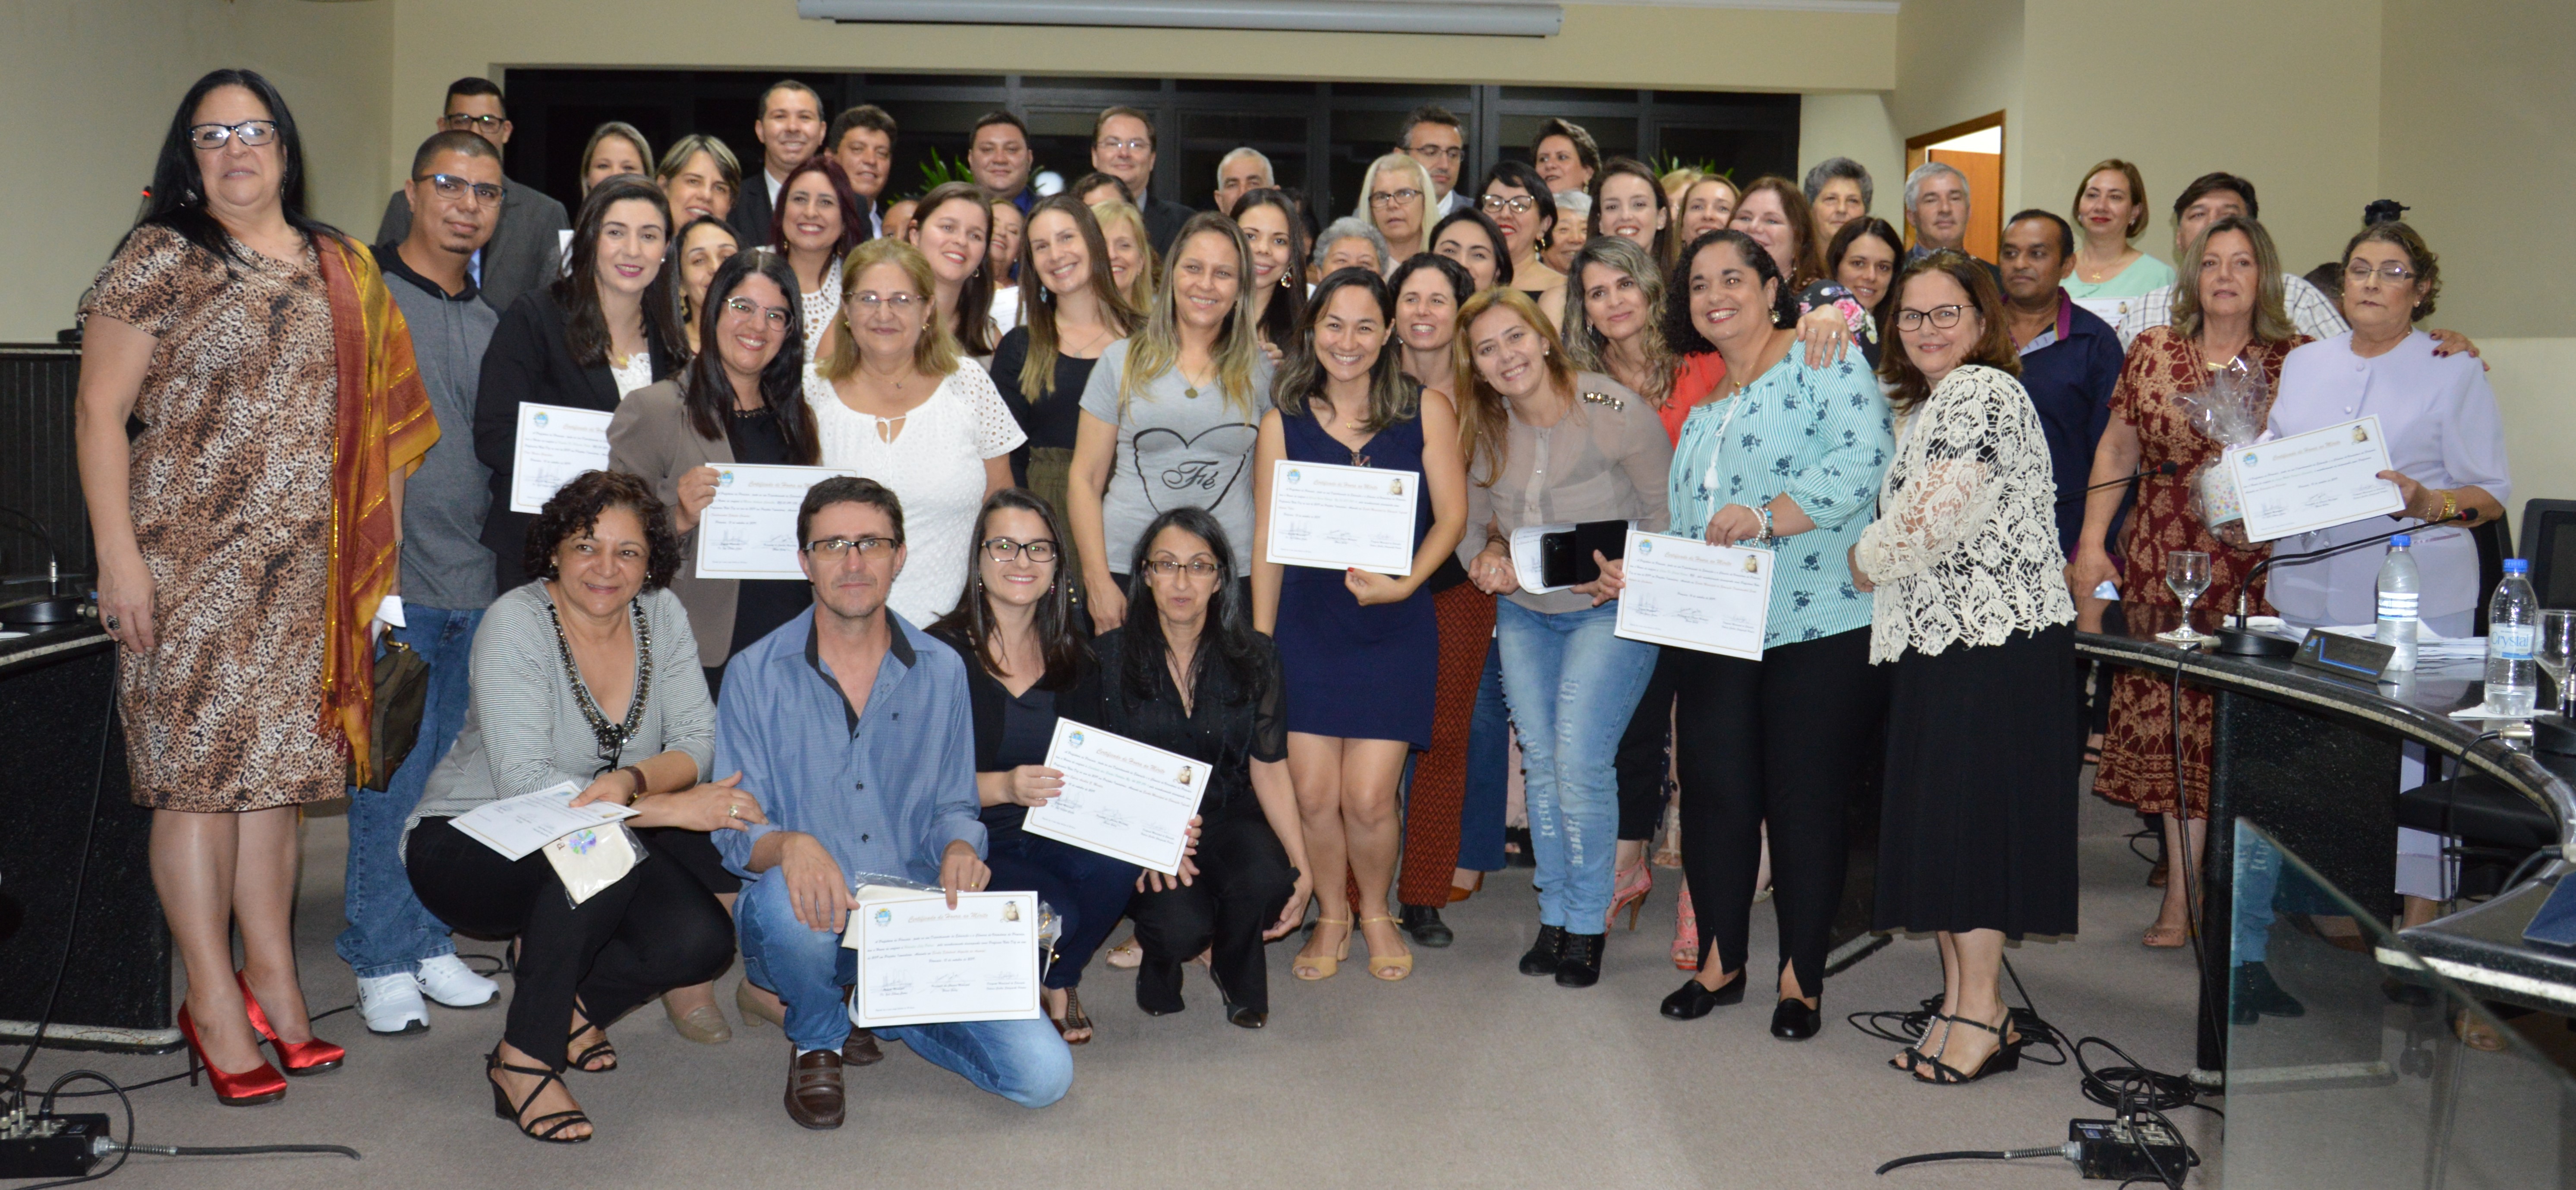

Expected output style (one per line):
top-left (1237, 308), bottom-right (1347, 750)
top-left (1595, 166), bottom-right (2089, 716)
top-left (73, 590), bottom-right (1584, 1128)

top-left (2094, 327), bottom-right (2308, 819)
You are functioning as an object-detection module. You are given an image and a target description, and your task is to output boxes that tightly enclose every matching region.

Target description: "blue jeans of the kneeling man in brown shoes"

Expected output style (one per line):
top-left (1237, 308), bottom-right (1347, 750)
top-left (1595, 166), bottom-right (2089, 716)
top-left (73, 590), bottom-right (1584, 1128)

top-left (734, 871), bottom-right (1074, 1108)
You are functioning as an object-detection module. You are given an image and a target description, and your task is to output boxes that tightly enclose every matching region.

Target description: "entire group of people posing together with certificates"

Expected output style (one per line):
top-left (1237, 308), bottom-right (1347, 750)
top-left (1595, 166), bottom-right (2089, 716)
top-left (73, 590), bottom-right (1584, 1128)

top-left (80, 69), bottom-right (2507, 1141)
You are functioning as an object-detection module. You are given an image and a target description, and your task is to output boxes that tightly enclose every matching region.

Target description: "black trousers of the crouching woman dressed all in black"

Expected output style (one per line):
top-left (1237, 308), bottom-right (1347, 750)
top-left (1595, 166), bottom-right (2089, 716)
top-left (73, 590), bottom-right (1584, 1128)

top-left (1128, 806), bottom-right (1288, 1015)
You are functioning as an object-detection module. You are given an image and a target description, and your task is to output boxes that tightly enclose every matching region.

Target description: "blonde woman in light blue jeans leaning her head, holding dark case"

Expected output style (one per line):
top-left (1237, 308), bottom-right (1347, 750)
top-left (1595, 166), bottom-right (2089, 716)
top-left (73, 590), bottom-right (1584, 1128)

top-left (1453, 288), bottom-right (1672, 987)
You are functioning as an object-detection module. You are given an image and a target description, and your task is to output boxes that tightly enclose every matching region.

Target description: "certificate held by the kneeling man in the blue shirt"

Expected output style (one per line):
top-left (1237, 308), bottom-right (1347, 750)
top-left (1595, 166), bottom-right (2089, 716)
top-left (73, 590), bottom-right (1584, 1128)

top-left (840, 884), bottom-right (1046, 1028)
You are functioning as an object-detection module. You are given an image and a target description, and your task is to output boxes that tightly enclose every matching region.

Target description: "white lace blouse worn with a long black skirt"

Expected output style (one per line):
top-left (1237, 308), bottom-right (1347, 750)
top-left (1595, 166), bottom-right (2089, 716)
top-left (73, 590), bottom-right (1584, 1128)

top-left (1855, 363), bottom-right (2076, 662)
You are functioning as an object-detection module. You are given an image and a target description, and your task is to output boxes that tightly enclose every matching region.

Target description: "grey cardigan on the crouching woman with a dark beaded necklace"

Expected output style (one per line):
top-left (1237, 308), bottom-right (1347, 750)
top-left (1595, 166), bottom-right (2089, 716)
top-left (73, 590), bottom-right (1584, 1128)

top-left (402, 582), bottom-right (716, 845)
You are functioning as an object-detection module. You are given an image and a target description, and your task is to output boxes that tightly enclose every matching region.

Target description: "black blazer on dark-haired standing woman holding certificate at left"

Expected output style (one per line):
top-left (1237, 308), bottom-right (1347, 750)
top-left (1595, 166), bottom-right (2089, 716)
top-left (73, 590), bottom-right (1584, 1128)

top-left (474, 286), bottom-right (680, 590)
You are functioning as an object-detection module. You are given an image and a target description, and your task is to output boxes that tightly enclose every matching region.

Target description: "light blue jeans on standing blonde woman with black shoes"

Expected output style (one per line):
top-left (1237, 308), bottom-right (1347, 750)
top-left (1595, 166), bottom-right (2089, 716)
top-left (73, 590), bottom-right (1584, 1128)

top-left (1494, 600), bottom-right (1656, 935)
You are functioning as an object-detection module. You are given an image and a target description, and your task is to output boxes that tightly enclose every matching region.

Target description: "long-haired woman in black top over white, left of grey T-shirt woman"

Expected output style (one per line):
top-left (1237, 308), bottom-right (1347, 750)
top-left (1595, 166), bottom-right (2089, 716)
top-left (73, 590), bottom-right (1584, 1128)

top-left (992, 193), bottom-right (1139, 582)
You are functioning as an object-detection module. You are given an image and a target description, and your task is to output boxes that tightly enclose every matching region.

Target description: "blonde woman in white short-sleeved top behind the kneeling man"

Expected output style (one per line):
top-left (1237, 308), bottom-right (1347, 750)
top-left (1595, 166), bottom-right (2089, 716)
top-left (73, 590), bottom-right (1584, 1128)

top-left (804, 234), bottom-right (1028, 626)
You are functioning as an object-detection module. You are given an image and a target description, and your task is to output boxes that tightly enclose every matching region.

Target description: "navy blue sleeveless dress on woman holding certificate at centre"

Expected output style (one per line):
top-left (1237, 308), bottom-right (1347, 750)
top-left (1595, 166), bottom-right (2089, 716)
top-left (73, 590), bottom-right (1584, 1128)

top-left (1272, 412), bottom-right (1440, 750)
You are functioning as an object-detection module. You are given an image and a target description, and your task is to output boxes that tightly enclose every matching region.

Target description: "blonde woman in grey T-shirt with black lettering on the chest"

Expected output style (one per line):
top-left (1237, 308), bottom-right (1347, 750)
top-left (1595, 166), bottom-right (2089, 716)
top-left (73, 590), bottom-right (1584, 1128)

top-left (1064, 211), bottom-right (1270, 631)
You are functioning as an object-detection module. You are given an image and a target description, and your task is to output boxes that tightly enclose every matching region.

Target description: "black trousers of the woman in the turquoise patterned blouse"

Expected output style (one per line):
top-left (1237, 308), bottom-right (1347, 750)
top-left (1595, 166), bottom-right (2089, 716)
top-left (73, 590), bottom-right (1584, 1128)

top-left (1664, 628), bottom-right (1888, 997)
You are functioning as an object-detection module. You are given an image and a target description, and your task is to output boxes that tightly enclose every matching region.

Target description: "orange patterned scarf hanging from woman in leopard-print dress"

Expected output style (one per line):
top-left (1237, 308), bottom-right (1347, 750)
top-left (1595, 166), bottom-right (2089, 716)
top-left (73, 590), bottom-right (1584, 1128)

top-left (314, 237), bottom-right (438, 773)
